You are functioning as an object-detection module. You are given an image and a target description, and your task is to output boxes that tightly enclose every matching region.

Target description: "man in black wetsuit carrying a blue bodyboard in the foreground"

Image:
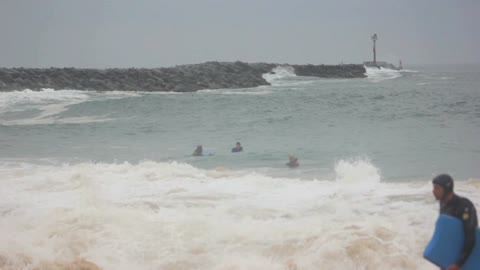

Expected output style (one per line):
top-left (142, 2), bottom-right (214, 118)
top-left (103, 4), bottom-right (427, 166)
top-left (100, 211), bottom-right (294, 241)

top-left (432, 174), bottom-right (480, 270)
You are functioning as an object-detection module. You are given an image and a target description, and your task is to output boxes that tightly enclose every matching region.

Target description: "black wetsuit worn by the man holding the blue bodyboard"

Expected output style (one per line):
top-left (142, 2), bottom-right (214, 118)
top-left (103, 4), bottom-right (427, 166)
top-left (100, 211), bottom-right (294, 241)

top-left (440, 194), bottom-right (478, 267)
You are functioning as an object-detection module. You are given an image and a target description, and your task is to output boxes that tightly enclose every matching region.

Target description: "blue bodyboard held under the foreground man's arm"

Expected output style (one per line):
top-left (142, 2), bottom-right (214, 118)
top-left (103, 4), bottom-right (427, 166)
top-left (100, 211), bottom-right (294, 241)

top-left (423, 215), bottom-right (480, 270)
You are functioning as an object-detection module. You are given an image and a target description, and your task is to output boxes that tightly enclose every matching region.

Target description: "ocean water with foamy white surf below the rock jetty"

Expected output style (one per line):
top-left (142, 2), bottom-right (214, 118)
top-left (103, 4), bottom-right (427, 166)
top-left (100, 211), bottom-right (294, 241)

top-left (0, 66), bottom-right (480, 270)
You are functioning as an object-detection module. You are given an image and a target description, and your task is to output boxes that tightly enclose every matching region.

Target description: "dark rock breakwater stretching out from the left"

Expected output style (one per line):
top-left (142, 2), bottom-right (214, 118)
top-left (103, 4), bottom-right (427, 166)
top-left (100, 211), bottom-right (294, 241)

top-left (0, 61), bottom-right (365, 92)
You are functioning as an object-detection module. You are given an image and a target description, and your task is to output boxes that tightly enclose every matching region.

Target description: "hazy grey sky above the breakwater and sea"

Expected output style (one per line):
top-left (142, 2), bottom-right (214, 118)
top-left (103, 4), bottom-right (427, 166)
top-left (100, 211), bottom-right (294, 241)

top-left (0, 0), bottom-right (480, 68)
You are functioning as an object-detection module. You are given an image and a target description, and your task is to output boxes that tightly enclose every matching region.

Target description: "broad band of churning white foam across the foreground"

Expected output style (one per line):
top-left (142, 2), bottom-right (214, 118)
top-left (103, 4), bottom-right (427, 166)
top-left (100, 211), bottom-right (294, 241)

top-left (0, 160), bottom-right (480, 270)
